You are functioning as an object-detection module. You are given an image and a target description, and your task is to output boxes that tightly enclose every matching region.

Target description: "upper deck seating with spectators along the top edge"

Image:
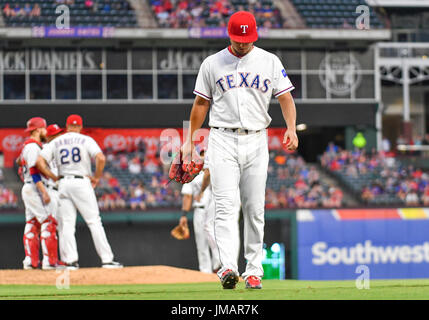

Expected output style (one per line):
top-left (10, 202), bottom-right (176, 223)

top-left (0, 0), bottom-right (386, 29)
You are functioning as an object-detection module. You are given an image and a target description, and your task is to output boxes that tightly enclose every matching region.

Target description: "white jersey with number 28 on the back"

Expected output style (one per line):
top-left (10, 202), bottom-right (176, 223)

top-left (41, 132), bottom-right (102, 176)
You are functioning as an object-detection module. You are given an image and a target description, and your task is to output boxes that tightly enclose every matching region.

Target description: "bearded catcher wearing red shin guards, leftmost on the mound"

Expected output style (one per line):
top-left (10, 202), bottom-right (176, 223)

top-left (20, 117), bottom-right (59, 270)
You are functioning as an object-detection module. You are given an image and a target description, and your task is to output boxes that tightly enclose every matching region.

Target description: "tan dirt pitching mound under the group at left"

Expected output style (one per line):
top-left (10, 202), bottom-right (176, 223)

top-left (0, 266), bottom-right (219, 285)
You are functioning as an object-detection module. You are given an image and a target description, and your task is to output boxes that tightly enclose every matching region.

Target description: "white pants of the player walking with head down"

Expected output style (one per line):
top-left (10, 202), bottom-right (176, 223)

top-left (207, 129), bottom-right (269, 279)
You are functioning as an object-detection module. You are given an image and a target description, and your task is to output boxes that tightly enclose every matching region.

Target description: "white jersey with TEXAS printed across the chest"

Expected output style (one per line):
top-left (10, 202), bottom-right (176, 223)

top-left (194, 46), bottom-right (294, 130)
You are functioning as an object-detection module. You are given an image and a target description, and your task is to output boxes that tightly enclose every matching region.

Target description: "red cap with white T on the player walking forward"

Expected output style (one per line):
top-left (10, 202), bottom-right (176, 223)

top-left (228, 11), bottom-right (258, 43)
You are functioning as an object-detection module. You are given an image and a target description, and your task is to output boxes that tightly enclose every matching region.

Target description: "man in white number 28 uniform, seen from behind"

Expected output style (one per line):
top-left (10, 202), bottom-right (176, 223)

top-left (37, 115), bottom-right (123, 269)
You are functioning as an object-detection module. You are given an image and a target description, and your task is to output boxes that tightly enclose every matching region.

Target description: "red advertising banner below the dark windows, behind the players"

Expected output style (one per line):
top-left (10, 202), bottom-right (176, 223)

top-left (0, 128), bottom-right (285, 167)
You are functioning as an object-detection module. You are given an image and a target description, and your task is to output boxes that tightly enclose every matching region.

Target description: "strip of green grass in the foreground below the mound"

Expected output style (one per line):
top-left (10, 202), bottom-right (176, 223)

top-left (0, 279), bottom-right (429, 300)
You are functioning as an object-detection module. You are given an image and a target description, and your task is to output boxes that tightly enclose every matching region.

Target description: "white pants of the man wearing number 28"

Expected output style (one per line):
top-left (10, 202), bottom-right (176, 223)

top-left (59, 177), bottom-right (113, 263)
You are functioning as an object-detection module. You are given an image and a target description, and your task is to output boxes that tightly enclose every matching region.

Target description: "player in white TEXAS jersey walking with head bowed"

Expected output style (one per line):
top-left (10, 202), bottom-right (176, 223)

top-left (182, 11), bottom-right (298, 289)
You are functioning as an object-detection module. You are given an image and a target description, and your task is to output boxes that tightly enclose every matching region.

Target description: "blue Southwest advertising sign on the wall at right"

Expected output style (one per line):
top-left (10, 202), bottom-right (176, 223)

top-left (297, 208), bottom-right (429, 280)
